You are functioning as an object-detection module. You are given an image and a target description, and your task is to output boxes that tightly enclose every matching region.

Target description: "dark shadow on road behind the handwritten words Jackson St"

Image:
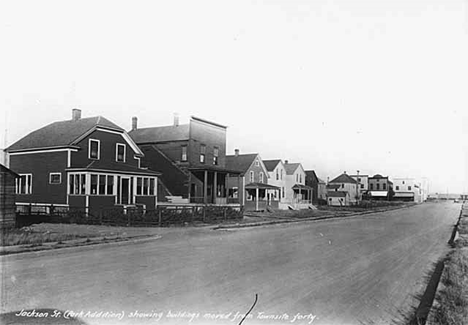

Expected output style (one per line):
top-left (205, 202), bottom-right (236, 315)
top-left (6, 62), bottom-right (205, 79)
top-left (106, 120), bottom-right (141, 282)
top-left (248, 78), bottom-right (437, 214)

top-left (0, 308), bottom-right (87, 325)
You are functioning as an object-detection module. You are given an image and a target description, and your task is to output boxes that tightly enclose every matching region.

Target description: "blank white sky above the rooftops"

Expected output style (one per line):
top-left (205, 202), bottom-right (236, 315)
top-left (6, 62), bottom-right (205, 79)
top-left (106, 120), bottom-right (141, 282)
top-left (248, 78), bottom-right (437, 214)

top-left (0, 0), bottom-right (468, 193)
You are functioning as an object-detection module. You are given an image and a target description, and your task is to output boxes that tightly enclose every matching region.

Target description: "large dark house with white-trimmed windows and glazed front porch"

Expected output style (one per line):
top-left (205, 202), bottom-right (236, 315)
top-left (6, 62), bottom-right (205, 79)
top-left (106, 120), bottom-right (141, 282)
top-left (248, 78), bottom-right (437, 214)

top-left (5, 109), bottom-right (160, 214)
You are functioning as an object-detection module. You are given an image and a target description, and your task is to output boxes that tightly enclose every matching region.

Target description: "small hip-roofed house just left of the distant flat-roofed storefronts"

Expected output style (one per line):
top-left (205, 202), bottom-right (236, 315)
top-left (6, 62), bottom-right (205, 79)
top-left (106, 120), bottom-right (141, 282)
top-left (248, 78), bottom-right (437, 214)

top-left (327, 173), bottom-right (360, 206)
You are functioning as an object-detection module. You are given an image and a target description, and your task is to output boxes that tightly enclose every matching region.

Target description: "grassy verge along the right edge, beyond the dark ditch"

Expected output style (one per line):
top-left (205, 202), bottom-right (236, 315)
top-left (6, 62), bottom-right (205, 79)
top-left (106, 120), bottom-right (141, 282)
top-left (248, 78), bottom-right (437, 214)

top-left (432, 204), bottom-right (468, 325)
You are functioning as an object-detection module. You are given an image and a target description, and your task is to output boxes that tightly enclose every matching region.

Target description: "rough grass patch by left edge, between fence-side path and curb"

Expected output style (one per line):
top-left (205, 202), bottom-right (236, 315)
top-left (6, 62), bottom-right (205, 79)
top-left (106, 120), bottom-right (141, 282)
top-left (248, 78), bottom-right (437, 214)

top-left (1, 227), bottom-right (88, 246)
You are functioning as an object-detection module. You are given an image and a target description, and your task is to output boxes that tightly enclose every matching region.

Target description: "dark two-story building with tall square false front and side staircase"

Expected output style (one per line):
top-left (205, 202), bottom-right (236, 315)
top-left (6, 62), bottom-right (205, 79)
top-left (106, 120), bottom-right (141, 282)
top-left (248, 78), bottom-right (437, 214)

top-left (129, 115), bottom-right (240, 205)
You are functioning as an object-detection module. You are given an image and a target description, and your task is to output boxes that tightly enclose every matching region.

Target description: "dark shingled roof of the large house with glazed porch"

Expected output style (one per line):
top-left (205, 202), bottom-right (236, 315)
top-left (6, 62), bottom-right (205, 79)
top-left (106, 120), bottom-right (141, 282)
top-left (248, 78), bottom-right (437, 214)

top-left (6, 116), bottom-right (124, 151)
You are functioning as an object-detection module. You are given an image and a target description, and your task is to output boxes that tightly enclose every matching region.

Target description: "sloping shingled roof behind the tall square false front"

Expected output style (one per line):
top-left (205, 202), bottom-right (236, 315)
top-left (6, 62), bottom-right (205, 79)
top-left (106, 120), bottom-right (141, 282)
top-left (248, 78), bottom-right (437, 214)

top-left (128, 124), bottom-right (190, 144)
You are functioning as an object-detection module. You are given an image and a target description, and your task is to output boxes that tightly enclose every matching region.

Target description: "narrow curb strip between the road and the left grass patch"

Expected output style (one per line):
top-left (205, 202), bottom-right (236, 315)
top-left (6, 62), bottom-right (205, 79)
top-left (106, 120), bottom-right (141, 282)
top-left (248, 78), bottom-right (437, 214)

top-left (0, 235), bottom-right (162, 256)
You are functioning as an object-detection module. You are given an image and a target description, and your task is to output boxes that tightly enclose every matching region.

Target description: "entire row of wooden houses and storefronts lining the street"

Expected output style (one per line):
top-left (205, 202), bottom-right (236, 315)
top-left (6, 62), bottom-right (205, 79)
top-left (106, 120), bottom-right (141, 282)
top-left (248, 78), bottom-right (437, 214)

top-left (0, 109), bottom-right (432, 223)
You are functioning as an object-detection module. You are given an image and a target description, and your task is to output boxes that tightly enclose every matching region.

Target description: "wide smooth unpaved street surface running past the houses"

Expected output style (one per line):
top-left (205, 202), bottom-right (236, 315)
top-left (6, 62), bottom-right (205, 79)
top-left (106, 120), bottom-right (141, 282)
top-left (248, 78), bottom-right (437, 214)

top-left (0, 203), bottom-right (461, 325)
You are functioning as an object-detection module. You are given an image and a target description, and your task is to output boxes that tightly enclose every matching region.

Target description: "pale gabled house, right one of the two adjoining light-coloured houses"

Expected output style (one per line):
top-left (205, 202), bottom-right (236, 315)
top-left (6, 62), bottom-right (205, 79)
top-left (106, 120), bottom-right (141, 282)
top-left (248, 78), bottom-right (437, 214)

top-left (280, 160), bottom-right (312, 209)
